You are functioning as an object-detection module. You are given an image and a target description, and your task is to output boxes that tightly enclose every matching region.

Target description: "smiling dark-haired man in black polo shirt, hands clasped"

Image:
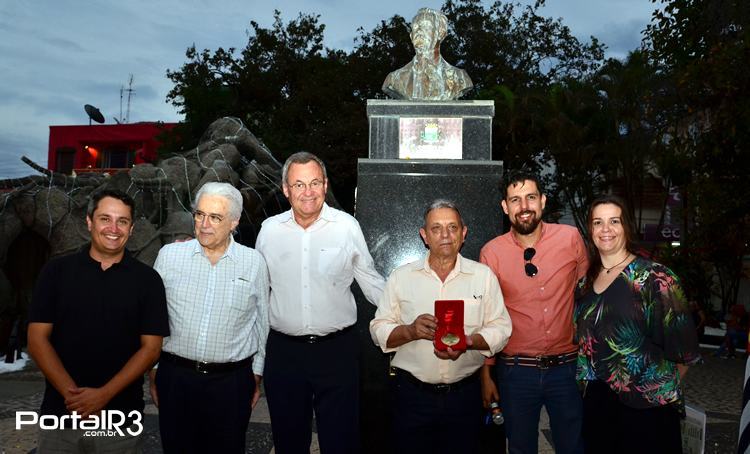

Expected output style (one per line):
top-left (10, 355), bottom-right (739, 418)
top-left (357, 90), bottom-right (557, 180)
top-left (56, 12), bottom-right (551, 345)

top-left (28, 189), bottom-right (169, 453)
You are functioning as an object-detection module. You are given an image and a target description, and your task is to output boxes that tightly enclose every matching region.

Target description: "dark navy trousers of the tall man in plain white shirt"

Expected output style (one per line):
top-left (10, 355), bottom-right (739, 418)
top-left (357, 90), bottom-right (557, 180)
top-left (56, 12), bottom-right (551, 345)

top-left (263, 329), bottom-right (360, 454)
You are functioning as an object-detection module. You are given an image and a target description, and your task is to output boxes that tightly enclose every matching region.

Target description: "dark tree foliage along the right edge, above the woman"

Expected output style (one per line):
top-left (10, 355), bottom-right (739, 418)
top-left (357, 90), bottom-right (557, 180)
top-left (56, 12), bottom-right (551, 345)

top-left (646, 0), bottom-right (750, 308)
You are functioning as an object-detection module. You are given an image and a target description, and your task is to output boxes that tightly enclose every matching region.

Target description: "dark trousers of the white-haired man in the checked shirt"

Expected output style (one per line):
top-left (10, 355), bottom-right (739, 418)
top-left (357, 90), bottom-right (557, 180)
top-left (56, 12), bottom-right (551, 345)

top-left (156, 361), bottom-right (255, 454)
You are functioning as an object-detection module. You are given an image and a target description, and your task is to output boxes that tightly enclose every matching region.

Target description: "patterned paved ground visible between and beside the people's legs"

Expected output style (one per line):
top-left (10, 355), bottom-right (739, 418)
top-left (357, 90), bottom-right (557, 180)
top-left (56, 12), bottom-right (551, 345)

top-left (0, 350), bottom-right (745, 454)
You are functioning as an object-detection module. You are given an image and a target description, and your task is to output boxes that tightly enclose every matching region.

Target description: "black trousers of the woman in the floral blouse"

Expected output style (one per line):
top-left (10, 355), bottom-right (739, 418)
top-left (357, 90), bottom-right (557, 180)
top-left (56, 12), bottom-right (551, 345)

top-left (583, 380), bottom-right (682, 454)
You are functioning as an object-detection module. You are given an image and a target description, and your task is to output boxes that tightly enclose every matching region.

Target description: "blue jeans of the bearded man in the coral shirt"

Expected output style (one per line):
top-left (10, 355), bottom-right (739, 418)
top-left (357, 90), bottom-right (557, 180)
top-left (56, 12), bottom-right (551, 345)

top-left (497, 361), bottom-right (583, 454)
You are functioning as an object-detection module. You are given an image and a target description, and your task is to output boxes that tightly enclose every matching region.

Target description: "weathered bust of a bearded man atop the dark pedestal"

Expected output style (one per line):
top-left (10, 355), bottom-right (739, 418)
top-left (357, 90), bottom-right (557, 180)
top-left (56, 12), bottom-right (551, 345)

top-left (383, 8), bottom-right (474, 101)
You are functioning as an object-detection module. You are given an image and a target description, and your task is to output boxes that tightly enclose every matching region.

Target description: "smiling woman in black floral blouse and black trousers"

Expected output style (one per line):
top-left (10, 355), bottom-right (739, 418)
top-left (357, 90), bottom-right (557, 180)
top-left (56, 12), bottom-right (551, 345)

top-left (575, 196), bottom-right (700, 454)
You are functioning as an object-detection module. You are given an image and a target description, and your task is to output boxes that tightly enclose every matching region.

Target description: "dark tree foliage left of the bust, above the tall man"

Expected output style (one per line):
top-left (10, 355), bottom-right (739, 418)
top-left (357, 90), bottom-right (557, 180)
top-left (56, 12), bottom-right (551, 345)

top-left (167, 11), bottom-right (367, 205)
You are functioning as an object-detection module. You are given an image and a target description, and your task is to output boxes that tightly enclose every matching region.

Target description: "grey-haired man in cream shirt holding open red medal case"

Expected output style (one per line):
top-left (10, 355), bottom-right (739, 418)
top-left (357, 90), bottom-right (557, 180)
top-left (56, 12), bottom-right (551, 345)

top-left (370, 200), bottom-right (511, 453)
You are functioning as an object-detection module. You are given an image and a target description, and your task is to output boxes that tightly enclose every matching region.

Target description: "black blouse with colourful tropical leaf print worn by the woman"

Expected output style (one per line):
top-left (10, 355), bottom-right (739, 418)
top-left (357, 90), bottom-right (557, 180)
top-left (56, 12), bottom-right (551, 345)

top-left (574, 257), bottom-right (700, 408)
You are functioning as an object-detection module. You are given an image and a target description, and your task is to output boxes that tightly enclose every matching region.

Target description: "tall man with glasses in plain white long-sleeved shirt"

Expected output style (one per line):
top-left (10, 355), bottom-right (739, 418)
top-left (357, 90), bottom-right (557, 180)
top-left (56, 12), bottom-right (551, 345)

top-left (256, 152), bottom-right (384, 454)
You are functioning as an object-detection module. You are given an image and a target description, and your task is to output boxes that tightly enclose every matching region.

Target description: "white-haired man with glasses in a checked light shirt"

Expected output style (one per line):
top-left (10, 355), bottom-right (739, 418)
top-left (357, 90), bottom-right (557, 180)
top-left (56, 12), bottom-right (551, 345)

top-left (152, 183), bottom-right (269, 454)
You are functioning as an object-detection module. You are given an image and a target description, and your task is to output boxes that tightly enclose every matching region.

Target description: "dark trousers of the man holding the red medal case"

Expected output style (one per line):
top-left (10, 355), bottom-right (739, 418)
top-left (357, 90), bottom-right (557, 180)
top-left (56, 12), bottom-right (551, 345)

top-left (393, 374), bottom-right (483, 454)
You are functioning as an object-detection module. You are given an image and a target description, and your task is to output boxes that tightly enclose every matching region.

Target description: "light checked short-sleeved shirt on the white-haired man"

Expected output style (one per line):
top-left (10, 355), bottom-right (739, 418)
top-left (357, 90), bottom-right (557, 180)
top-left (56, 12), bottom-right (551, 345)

top-left (154, 237), bottom-right (269, 375)
